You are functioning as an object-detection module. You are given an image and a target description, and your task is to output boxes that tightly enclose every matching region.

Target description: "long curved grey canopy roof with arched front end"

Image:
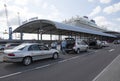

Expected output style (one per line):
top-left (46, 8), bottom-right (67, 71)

top-left (13, 19), bottom-right (115, 37)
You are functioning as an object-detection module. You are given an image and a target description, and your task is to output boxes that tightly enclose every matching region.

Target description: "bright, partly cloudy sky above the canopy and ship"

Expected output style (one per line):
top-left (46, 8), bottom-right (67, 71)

top-left (0, 0), bottom-right (120, 37)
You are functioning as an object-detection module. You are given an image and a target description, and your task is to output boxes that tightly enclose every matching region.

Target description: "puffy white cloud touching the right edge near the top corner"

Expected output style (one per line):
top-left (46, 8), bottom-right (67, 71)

top-left (103, 2), bottom-right (120, 14)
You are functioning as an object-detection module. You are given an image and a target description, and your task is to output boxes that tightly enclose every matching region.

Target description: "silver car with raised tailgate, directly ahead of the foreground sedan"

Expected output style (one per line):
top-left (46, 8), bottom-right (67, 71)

top-left (65, 38), bottom-right (88, 54)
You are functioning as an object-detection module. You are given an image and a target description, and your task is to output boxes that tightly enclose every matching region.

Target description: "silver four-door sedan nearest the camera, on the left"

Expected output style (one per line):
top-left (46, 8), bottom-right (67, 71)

top-left (3, 43), bottom-right (59, 65)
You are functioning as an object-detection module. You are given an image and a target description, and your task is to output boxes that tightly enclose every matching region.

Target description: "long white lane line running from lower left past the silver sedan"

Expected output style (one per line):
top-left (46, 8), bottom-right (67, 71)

top-left (0, 56), bottom-right (80, 79)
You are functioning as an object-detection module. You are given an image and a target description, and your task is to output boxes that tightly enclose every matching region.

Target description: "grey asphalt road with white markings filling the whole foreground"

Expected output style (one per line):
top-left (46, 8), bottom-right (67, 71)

top-left (0, 45), bottom-right (120, 81)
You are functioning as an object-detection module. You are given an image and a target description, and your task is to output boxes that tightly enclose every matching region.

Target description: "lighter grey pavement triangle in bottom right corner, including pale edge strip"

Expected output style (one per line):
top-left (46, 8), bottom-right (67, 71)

top-left (93, 55), bottom-right (120, 81)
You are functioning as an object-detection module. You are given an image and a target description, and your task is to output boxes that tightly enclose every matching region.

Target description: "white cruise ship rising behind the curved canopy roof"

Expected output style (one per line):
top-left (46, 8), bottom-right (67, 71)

top-left (63, 16), bottom-right (107, 32)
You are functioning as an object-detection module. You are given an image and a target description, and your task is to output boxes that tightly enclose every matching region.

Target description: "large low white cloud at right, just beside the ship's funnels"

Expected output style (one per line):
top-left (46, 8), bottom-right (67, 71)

top-left (94, 16), bottom-right (120, 32)
